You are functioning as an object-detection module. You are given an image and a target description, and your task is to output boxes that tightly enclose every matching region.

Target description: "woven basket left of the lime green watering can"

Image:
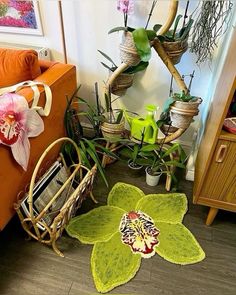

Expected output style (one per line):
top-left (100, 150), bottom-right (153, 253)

top-left (101, 120), bottom-right (125, 142)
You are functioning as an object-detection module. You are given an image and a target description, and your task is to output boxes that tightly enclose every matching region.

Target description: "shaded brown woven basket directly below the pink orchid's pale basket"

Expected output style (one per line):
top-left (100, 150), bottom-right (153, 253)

top-left (109, 72), bottom-right (134, 96)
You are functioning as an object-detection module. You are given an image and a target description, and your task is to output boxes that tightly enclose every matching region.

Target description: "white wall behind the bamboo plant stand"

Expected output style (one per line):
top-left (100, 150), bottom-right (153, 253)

top-left (0, 0), bottom-right (232, 145)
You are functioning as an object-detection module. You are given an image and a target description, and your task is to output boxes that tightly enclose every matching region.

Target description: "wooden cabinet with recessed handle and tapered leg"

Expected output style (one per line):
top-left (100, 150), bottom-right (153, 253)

top-left (193, 33), bottom-right (236, 225)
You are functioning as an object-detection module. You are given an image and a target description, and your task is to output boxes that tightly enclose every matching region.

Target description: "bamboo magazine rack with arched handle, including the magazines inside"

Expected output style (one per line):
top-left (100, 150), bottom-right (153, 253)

top-left (15, 137), bottom-right (97, 257)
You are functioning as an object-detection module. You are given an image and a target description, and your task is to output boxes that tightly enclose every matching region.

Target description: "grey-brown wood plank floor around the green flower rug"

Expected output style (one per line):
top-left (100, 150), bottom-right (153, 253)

top-left (0, 163), bottom-right (236, 295)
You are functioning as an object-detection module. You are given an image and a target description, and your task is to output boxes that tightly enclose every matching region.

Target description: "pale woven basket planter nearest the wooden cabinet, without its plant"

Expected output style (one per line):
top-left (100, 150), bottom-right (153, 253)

top-left (170, 98), bottom-right (202, 129)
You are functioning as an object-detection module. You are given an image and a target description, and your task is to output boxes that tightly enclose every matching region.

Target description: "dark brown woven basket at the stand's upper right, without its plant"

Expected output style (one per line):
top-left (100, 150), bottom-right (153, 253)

top-left (162, 39), bottom-right (188, 65)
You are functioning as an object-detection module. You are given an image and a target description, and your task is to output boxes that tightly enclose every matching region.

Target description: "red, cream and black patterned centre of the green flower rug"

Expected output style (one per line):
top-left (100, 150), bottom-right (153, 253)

top-left (119, 211), bottom-right (160, 258)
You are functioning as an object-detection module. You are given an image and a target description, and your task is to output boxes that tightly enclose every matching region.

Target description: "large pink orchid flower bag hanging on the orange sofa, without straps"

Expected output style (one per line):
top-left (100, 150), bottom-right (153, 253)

top-left (0, 93), bottom-right (44, 171)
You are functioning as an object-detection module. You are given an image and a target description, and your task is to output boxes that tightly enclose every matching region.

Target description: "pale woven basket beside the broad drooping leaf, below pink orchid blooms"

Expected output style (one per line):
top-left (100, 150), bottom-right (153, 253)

top-left (120, 32), bottom-right (141, 66)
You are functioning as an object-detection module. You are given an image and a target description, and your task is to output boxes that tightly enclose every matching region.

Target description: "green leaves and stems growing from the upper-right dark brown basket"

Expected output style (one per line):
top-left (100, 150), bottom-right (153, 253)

top-left (153, 14), bottom-right (194, 42)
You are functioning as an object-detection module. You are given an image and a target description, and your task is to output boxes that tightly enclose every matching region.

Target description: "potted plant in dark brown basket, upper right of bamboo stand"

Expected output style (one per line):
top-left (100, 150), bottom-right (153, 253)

top-left (153, 11), bottom-right (193, 65)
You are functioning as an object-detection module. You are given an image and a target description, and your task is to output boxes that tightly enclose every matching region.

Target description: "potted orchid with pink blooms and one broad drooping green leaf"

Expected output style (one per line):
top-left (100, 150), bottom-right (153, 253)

top-left (109, 0), bottom-right (157, 66)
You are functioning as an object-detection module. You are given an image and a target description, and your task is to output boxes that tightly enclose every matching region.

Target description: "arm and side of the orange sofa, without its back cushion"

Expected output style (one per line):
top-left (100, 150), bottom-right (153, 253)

top-left (0, 56), bottom-right (77, 231)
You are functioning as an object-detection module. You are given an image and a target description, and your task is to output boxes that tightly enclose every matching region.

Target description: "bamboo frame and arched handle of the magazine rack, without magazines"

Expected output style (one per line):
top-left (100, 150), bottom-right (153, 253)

top-left (15, 137), bottom-right (97, 257)
